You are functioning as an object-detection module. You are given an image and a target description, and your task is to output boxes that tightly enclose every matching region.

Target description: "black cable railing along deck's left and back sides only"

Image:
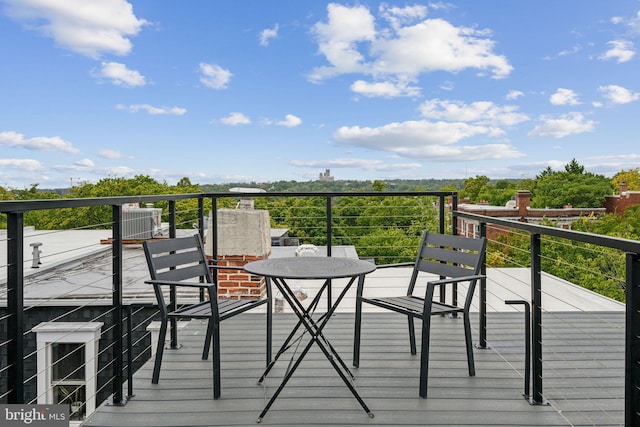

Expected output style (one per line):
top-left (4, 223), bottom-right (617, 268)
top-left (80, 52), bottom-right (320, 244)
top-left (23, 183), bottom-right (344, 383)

top-left (0, 192), bottom-right (455, 420)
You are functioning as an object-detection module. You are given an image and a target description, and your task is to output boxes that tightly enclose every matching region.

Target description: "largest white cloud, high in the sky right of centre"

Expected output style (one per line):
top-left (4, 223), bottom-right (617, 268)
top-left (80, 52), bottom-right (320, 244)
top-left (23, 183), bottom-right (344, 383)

top-left (309, 3), bottom-right (513, 81)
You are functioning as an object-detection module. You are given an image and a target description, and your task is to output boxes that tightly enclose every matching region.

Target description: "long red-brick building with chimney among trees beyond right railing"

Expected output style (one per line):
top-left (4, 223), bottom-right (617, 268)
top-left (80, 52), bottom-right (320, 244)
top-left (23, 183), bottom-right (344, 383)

top-left (458, 190), bottom-right (606, 239)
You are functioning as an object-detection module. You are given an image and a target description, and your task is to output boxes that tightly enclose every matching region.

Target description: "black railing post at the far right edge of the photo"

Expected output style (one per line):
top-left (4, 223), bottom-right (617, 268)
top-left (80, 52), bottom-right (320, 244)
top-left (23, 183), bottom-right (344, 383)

top-left (624, 253), bottom-right (640, 426)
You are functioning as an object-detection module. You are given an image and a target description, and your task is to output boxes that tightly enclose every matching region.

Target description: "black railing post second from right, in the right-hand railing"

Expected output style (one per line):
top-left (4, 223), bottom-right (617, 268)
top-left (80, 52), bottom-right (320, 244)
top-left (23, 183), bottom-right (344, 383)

top-left (529, 233), bottom-right (545, 405)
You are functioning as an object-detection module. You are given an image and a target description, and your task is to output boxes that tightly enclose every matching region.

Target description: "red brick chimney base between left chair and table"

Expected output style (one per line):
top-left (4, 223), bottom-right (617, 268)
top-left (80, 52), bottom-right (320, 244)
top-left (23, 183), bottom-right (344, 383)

top-left (211, 255), bottom-right (267, 299)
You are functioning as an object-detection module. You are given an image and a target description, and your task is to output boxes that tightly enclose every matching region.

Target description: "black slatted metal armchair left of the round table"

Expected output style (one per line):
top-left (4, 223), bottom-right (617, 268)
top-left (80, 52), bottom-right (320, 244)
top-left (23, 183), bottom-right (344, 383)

top-left (143, 234), bottom-right (272, 399)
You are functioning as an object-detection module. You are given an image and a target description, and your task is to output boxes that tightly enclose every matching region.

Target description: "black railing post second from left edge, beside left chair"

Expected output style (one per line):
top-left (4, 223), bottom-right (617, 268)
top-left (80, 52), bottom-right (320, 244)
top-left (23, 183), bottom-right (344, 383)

top-left (111, 205), bottom-right (126, 405)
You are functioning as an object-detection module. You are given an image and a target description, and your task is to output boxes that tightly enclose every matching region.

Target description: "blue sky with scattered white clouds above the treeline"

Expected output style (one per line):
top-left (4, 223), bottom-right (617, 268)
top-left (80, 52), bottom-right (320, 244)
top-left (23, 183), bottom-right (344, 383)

top-left (0, 0), bottom-right (640, 188)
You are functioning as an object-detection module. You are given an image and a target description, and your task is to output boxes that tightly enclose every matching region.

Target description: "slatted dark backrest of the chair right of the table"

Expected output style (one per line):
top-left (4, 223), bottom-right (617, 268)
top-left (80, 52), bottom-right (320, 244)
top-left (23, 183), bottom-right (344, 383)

top-left (409, 231), bottom-right (486, 294)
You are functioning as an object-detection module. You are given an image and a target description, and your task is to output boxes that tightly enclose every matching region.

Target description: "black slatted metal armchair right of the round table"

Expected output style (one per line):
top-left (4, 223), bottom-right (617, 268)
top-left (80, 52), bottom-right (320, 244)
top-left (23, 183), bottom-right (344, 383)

top-left (353, 232), bottom-right (486, 398)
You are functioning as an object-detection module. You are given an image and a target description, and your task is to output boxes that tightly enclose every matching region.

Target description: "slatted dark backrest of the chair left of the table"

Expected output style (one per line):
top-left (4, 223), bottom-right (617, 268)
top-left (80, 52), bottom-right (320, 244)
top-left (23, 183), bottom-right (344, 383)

top-left (142, 234), bottom-right (213, 283)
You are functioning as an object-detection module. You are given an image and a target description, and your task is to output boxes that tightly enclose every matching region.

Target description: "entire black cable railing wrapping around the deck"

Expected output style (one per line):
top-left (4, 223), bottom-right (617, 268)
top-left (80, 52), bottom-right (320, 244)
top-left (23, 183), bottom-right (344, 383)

top-left (0, 192), bottom-right (640, 425)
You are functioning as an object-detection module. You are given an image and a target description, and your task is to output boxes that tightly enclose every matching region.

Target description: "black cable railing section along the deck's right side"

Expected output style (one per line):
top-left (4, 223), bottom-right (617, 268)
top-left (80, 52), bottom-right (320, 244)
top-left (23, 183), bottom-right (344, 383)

top-left (457, 213), bottom-right (640, 425)
